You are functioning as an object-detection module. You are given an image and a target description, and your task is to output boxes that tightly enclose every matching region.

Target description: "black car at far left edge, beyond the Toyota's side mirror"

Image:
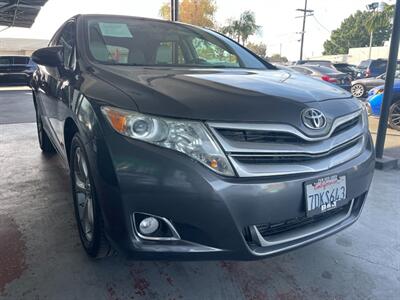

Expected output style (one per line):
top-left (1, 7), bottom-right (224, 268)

top-left (0, 56), bottom-right (36, 85)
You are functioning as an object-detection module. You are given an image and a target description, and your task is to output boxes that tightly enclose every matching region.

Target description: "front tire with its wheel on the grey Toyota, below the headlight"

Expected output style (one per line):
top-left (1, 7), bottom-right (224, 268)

top-left (70, 133), bottom-right (114, 259)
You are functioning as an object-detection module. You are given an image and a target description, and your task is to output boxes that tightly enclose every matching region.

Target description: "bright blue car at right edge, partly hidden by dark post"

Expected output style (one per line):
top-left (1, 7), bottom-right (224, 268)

top-left (367, 80), bottom-right (400, 130)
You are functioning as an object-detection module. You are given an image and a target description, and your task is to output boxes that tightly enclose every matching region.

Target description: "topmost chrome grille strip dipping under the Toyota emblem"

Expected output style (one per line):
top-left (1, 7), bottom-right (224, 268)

top-left (207, 109), bottom-right (362, 143)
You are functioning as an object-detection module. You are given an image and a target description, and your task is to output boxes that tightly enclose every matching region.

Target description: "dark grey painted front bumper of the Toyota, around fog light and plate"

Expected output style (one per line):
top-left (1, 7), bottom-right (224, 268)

top-left (89, 133), bottom-right (374, 260)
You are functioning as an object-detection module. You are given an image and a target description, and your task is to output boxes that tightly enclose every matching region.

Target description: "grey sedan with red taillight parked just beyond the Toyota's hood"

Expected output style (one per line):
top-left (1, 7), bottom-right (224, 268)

top-left (291, 65), bottom-right (351, 91)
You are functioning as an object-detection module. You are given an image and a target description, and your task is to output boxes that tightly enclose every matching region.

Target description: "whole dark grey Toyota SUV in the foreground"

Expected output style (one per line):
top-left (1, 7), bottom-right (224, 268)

top-left (32, 15), bottom-right (374, 259)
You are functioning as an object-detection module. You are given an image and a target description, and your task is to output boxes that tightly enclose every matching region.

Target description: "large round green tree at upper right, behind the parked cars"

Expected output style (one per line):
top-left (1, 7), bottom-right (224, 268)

top-left (323, 5), bottom-right (393, 55)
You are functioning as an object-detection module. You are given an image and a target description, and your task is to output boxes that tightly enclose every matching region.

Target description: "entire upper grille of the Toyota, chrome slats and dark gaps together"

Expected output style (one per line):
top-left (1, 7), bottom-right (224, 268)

top-left (208, 110), bottom-right (366, 177)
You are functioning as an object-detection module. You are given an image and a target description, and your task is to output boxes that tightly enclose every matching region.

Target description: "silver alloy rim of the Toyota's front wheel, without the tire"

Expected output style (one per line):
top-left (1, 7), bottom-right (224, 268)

top-left (74, 147), bottom-right (94, 242)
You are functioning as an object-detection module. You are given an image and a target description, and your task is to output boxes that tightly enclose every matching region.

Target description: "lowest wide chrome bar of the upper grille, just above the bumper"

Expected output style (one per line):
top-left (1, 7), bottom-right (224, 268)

top-left (228, 135), bottom-right (366, 177)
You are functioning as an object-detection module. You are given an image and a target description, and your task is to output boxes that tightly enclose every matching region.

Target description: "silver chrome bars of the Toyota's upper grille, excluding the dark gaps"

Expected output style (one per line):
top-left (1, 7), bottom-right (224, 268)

top-left (207, 108), bottom-right (368, 177)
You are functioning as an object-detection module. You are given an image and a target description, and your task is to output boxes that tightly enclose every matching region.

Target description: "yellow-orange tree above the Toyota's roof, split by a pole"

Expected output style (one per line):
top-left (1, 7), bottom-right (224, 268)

top-left (160, 0), bottom-right (217, 28)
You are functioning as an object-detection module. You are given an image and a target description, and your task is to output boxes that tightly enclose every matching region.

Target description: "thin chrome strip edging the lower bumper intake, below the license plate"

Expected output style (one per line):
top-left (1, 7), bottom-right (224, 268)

top-left (250, 199), bottom-right (354, 247)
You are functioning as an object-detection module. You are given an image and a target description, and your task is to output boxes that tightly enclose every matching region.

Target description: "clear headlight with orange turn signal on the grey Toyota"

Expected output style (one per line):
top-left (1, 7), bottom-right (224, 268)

top-left (101, 106), bottom-right (235, 176)
